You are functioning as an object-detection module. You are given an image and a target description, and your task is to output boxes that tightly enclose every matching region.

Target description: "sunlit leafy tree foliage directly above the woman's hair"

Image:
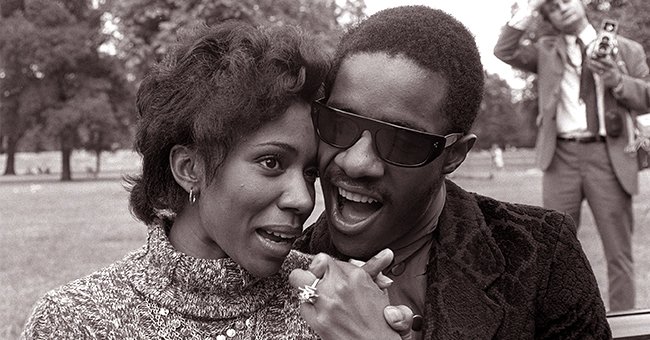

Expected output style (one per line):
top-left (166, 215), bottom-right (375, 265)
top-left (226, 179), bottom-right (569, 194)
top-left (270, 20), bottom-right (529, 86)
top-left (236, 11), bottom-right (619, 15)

top-left (110, 0), bottom-right (365, 79)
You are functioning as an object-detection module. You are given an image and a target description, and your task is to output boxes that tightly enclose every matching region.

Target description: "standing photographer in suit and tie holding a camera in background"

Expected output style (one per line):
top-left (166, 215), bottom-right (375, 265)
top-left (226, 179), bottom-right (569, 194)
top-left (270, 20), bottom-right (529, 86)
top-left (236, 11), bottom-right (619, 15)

top-left (494, 0), bottom-right (650, 311)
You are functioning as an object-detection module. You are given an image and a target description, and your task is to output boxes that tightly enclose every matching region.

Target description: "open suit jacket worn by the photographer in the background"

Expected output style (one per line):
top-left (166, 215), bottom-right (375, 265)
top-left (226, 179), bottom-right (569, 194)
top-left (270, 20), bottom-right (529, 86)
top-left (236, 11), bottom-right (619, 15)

top-left (494, 26), bottom-right (650, 195)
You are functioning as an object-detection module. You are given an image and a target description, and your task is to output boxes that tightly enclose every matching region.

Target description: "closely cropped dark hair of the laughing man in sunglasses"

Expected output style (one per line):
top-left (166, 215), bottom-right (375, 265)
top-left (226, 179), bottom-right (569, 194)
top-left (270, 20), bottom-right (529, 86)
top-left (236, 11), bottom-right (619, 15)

top-left (325, 6), bottom-right (484, 132)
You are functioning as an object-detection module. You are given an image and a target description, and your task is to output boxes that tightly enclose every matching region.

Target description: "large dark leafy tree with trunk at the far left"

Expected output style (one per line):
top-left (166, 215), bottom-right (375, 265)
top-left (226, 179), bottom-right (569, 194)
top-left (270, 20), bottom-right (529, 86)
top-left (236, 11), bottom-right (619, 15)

top-left (0, 0), bottom-right (133, 180)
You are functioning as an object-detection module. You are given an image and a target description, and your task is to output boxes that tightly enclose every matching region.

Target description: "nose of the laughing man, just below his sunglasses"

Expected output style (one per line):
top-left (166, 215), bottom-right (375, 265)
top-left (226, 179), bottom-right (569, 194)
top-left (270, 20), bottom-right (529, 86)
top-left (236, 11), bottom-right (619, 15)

top-left (334, 130), bottom-right (386, 178)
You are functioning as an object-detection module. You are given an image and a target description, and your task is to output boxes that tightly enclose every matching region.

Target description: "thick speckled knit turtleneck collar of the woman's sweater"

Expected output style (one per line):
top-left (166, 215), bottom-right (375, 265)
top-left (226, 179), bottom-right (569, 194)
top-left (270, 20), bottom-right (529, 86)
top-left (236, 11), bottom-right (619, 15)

top-left (128, 225), bottom-right (288, 319)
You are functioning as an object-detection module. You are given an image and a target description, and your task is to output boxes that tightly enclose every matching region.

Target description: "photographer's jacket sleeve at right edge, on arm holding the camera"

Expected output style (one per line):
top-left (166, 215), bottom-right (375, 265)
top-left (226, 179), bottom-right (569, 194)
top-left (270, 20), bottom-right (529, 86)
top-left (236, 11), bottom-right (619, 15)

top-left (613, 41), bottom-right (650, 113)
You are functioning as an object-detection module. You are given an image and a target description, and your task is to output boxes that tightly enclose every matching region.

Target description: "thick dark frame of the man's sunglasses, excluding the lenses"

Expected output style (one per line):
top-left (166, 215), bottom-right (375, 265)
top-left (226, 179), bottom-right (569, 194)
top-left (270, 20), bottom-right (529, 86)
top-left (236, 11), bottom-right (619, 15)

top-left (312, 98), bottom-right (464, 168)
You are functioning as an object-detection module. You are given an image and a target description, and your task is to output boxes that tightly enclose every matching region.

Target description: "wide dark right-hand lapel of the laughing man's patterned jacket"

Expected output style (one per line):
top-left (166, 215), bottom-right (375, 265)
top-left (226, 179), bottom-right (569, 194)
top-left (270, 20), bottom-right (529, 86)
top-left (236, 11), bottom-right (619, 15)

top-left (425, 181), bottom-right (505, 339)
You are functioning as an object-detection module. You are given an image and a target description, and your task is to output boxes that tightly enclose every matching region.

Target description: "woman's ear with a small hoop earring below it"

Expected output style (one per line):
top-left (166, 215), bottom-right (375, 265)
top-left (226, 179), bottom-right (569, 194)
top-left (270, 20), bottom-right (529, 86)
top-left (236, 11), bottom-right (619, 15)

top-left (169, 145), bottom-right (202, 192)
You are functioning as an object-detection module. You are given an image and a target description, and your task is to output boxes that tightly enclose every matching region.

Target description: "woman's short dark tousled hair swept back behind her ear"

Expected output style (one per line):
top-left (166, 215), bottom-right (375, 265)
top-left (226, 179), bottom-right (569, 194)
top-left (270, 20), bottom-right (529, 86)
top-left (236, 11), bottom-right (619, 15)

top-left (127, 21), bottom-right (329, 224)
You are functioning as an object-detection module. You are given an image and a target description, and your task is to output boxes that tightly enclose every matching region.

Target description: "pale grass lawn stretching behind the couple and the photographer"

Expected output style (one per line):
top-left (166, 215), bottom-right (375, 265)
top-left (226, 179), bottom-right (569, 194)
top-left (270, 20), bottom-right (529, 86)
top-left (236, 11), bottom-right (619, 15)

top-left (0, 150), bottom-right (650, 339)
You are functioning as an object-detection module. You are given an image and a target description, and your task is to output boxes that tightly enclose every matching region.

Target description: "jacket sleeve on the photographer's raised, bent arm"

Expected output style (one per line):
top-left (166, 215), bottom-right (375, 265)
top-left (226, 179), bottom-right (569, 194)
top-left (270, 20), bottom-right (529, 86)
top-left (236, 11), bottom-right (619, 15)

top-left (494, 25), bottom-right (538, 73)
